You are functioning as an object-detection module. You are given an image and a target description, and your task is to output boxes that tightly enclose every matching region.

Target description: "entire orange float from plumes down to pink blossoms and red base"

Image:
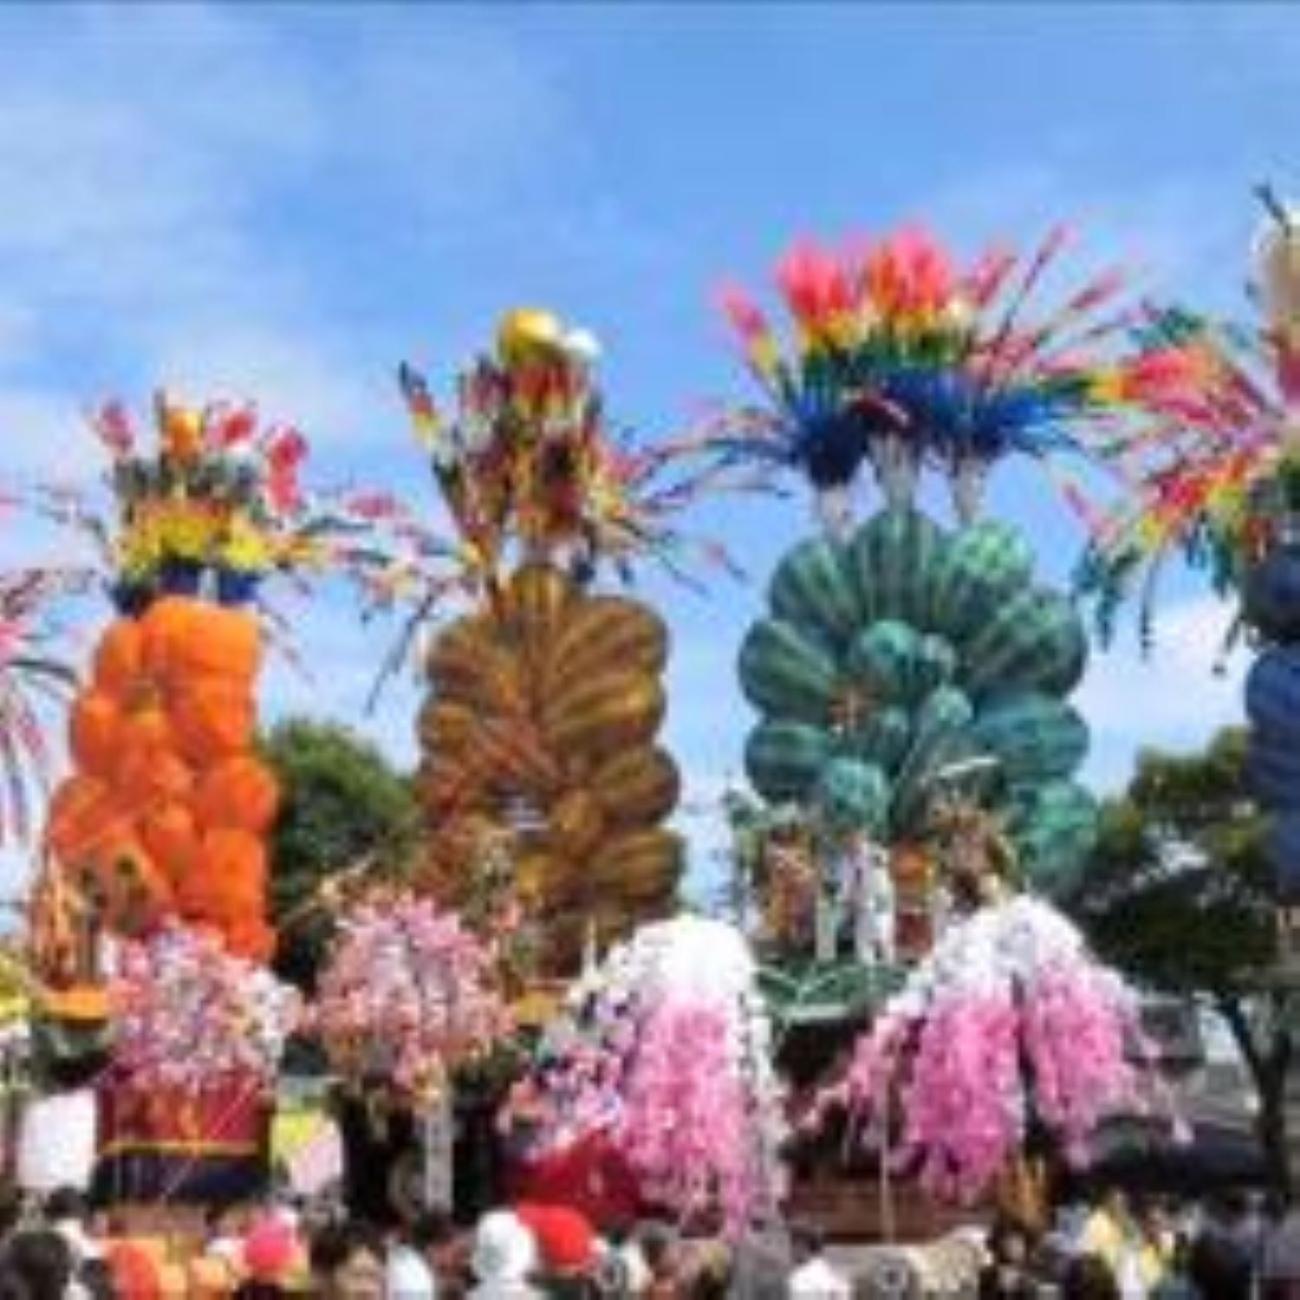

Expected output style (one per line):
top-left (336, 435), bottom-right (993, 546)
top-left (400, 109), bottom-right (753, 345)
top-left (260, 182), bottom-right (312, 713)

top-left (29, 394), bottom-right (377, 1204)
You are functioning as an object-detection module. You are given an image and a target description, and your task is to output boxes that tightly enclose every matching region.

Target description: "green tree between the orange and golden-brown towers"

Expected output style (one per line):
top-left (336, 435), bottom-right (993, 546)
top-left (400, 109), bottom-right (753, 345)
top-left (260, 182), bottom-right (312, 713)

top-left (264, 718), bottom-right (420, 989)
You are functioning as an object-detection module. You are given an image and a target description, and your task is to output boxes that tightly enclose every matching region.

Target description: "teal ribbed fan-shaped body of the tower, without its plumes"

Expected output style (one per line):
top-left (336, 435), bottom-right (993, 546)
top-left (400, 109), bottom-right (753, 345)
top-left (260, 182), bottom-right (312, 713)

top-left (740, 510), bottom-right (1096, 888)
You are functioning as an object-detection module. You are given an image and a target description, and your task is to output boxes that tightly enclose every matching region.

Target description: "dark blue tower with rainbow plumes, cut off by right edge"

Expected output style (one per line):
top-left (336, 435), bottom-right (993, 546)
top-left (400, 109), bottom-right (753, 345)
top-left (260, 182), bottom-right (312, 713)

top-left (1079, 191), bottom-right (1300, 905)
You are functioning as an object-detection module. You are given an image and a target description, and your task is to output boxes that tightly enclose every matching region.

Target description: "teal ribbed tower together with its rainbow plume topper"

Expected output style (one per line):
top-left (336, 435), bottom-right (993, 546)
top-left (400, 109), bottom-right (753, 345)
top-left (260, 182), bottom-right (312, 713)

top-left (718, 229), bottom-right (1170, 915)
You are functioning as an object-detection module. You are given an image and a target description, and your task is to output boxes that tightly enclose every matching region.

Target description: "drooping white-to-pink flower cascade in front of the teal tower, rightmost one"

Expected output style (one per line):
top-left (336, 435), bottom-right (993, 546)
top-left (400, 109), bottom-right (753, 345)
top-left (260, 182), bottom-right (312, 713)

top-left (814, 898), bottom-right (1154, 1200)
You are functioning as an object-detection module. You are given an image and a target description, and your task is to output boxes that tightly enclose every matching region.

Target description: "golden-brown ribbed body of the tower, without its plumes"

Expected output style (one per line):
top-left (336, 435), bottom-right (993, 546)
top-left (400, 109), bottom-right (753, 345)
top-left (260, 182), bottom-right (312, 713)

top-left (419, 564), bottom-right (681, 971)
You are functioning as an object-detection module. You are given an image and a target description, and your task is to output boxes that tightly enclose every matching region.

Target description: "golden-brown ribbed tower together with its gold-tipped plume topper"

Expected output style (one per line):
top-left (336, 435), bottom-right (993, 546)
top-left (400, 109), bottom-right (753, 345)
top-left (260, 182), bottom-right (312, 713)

top-left (384, 309), bottom-right (748, 975)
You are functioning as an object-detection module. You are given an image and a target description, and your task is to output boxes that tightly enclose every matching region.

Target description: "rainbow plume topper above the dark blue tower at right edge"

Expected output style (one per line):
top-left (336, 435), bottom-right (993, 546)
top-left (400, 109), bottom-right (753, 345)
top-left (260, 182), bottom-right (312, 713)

top-left (1078, 195), bottom-right (1300, 640)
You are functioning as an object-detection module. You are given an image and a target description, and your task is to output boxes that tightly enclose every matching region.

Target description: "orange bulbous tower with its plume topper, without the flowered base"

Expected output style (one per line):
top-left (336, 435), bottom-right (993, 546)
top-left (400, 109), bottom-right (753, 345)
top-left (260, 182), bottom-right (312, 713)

top-left (46, 397), bottom-right (296, 961)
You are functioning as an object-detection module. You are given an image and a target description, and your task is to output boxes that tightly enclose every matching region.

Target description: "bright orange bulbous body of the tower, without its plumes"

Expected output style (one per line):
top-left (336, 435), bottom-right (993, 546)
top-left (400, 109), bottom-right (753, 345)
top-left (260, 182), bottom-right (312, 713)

top-left (47, 595), bottom-right (277, 961)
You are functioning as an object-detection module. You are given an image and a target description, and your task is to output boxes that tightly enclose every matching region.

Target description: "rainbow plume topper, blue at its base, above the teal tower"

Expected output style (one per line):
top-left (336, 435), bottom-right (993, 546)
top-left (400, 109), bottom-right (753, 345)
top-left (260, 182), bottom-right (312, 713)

top-left (715, 229), bottom-right (1130, 524)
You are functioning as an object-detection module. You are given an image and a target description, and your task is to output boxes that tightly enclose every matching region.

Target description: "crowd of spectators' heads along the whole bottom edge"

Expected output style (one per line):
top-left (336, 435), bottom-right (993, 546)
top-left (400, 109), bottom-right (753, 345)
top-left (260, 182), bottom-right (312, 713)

top-left (0, 1191), bottom-right (1300, 1300)
